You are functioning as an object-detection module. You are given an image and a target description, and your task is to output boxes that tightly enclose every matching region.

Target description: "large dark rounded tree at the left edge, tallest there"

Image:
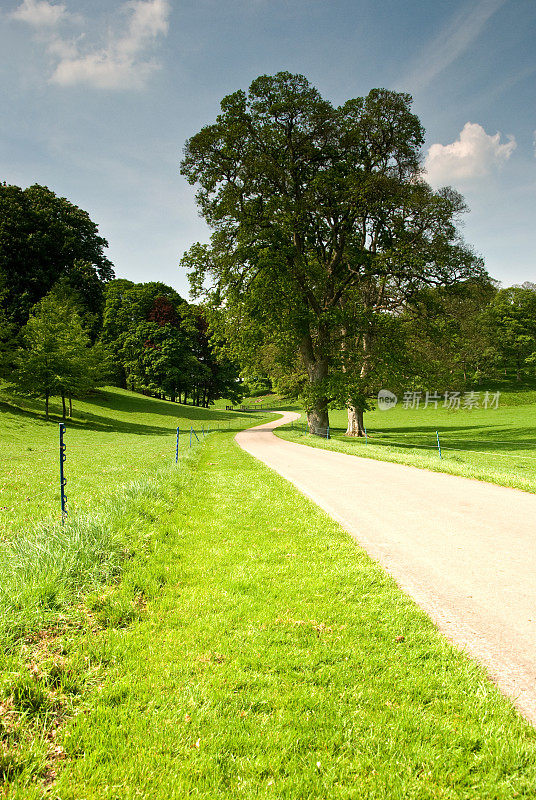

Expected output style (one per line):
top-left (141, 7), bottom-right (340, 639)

top-left (0, 183), bottom-right (114, 333)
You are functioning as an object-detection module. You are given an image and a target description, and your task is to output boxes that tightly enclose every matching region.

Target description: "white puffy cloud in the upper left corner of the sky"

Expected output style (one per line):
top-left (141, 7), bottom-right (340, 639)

top-left (12, 0), bottom-right (170, 89)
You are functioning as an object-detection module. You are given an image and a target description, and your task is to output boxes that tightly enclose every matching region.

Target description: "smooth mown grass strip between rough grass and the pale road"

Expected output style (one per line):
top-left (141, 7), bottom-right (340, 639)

top-left (3, 433), bottom-right (536, 800)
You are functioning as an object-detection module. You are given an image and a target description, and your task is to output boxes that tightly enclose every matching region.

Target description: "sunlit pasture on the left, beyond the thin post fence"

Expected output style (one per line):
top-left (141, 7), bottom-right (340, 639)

top-left (0, 387), bottom-right (262, 540)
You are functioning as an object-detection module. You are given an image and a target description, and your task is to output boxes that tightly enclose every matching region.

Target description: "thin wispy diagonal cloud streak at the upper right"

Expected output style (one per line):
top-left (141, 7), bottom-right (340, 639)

top-left (400, 0), bottom-right (506, 92)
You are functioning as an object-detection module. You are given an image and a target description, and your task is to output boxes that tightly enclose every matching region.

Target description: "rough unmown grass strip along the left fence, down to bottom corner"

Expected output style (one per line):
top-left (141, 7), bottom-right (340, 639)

top-left (0, 448), bottom-right (206, 797)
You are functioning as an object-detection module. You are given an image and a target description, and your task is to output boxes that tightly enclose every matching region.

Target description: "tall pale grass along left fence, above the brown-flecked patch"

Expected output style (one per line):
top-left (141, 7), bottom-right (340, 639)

top-left (0, 450), bottom-right (196, 649)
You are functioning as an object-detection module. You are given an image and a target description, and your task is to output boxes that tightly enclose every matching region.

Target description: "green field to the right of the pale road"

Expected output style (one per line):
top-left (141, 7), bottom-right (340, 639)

top-left (277, 389), bottom-right (536, 492)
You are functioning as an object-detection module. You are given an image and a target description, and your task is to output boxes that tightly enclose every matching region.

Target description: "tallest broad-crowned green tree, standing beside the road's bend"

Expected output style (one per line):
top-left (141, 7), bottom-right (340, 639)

top-left (182, 72), bottom-right (483, 429)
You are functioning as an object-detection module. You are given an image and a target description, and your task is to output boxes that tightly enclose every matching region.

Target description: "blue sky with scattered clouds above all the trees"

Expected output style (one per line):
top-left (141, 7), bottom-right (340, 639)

top-left (0, 0), bottom-right (536, 297)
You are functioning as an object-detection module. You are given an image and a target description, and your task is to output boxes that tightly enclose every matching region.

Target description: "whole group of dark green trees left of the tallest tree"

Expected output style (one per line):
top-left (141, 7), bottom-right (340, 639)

top-left (0, 183), bottom-right (240, 418)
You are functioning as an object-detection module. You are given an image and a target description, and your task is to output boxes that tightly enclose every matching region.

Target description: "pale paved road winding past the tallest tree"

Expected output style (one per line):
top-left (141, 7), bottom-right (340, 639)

top-left (236, 412), bottom-right (536, 724)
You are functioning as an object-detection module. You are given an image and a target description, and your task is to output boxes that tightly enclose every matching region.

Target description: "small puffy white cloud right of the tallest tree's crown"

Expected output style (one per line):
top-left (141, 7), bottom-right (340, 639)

top-left (424, 122), bottom-right (516, 186)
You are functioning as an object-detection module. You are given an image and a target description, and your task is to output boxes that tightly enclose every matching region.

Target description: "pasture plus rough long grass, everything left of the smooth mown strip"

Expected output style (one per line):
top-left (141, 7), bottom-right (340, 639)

top-left (0, 389), bottom-right (272, 794)
